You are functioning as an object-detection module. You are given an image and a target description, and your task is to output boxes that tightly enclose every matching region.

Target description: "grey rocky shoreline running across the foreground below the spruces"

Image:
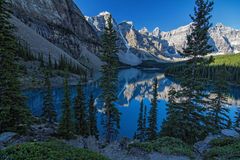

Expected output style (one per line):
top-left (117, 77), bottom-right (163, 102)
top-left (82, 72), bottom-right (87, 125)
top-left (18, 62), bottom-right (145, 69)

top-left (0, 124), bottom-right (240, 160)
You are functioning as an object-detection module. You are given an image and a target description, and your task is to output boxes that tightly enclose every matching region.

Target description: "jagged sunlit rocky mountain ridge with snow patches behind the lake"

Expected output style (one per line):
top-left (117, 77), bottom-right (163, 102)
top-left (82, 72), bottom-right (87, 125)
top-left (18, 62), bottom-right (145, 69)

top-left (85, 12), bottom-right (240, 62)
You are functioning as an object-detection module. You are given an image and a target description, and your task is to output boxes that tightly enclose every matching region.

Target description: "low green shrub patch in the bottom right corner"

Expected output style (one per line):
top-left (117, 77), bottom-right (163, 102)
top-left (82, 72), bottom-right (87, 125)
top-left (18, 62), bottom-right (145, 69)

top-left (205, 138), bottom-right (240, 160)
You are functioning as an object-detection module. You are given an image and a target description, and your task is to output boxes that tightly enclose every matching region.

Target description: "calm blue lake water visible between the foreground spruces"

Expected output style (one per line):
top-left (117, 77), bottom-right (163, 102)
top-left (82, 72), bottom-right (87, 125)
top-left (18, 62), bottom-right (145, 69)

top-left (24, 68), bottom-right (240, 138)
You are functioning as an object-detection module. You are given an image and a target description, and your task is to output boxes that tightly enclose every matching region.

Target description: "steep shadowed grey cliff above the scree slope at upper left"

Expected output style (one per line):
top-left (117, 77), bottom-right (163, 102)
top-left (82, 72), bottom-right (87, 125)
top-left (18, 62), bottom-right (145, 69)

top-left (9, 0), bottom-right (100, 68)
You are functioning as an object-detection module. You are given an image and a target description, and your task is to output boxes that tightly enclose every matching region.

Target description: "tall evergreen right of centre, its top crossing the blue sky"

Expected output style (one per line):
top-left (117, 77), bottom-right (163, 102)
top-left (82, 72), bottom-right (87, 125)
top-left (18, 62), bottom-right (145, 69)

top-left (161, 0), bottom-right (213, 143)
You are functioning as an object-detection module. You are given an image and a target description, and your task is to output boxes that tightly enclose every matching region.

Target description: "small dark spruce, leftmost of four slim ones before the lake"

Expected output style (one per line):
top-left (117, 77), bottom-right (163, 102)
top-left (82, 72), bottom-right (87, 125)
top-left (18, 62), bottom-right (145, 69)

top-left (42, 70), bottom-right (56, 123)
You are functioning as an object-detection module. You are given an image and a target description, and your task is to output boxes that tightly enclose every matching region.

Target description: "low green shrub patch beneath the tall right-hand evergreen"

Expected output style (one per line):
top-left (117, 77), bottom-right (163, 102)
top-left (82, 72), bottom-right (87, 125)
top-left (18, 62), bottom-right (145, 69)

top-left (130, 137), bottom-right (193, 157)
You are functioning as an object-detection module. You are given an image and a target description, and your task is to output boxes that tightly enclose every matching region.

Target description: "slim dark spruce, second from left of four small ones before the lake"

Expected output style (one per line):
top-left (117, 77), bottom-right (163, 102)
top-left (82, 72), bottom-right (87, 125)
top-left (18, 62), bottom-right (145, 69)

top-left (58, 76), bottom-right (74, 139)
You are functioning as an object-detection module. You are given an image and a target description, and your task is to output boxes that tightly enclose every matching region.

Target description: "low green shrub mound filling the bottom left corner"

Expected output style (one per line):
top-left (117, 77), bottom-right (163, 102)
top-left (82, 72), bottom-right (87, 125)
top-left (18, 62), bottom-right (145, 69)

top-left (0, 141), bottom-right (107, 160)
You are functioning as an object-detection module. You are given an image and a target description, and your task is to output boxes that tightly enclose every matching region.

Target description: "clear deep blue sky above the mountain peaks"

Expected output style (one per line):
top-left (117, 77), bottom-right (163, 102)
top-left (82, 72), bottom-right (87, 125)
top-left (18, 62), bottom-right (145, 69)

top-left (74, 0), bottom-right (240, 31)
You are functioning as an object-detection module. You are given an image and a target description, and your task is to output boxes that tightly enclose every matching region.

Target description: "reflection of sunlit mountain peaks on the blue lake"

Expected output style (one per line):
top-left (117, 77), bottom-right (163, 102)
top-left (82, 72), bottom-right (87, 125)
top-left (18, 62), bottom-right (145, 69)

top-left (118, 68), bottom-right (240, 107)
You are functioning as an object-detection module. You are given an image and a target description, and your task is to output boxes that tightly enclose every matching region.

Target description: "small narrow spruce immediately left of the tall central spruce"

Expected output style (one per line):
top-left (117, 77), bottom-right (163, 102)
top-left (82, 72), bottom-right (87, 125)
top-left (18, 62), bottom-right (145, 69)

top-left (88, 94), bottom-right (98, 138)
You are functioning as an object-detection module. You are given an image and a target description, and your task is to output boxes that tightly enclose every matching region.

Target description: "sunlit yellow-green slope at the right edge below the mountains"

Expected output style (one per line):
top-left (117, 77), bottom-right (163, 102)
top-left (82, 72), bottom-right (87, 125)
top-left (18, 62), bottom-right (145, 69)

top-left (211, 53), bottom-right (240, 67)
